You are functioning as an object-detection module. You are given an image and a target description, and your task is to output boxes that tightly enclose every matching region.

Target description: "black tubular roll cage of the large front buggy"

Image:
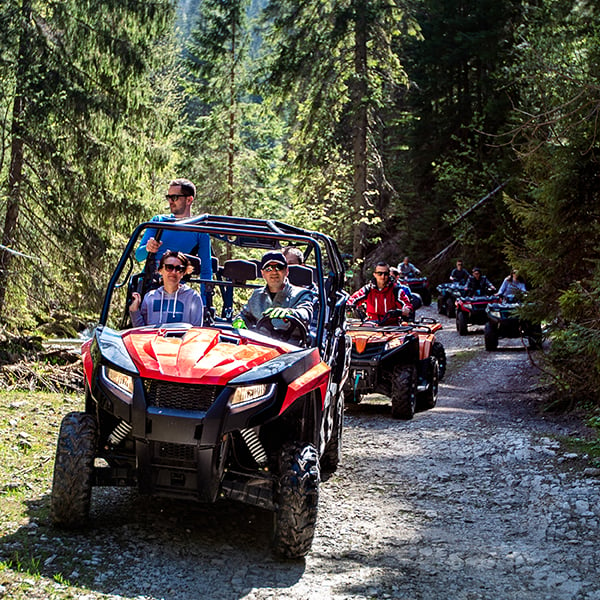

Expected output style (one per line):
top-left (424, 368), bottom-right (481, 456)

top-left (99, 214), bottom-right (345, 347)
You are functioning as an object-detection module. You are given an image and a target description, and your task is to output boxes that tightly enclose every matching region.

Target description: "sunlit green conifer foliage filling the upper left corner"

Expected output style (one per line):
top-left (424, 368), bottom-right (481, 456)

top-left (0, 0), bottom-right (180, 323)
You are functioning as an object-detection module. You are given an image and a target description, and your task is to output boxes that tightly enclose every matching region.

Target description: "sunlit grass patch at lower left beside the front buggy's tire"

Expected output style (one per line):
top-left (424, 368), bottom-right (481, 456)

top-left (0, 391), bottom-right (84, 600)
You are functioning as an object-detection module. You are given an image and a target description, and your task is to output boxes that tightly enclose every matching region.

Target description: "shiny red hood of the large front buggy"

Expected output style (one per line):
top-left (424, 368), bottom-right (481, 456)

top-left (122, 328), bottom-right (297, 385)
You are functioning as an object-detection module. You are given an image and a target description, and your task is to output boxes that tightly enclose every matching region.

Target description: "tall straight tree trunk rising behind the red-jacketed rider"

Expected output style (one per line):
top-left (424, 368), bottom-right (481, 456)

top-left (351, 2), bottom-right (369, 288)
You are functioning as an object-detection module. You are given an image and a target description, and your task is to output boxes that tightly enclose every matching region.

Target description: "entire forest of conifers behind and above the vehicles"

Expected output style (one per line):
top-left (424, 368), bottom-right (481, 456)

top-left (0, 0), bottom-right (600, 406)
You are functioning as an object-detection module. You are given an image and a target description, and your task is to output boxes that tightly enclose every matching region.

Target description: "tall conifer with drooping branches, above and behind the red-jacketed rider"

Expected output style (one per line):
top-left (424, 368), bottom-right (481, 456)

top-left (266, 0), bottom-right (417, 285)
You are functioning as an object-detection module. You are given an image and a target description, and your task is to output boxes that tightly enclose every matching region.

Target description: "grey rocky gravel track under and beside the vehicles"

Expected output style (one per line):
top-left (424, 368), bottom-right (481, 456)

top-left (0, 308), bottom-right (600, 600)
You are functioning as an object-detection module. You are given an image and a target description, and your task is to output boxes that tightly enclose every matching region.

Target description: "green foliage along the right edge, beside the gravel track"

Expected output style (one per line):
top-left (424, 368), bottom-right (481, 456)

top-left (507, 0), bottom-right (600, 404)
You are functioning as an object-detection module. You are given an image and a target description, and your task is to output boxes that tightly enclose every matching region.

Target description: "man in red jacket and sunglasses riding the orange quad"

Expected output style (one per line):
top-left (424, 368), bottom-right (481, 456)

top-left (347, 262), bottom-right (412, 324)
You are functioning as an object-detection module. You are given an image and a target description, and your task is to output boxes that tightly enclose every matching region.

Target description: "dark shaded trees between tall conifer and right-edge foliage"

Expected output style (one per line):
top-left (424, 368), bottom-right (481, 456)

top-left (388, 0), bottom-right (520, 278)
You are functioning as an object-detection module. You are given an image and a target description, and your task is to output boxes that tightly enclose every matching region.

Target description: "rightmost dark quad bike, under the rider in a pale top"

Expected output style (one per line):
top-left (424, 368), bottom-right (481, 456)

top-left (483, 296), bottom-right (542, 351)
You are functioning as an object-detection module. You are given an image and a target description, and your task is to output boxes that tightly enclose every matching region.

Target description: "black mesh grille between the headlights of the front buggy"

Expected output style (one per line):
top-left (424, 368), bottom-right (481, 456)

top-left (144, 379), bottom-right (223, 412)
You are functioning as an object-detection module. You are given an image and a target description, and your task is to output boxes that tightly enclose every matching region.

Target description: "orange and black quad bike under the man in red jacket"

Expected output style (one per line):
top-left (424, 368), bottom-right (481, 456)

top-left (344, 311), bottom-right (446, 419)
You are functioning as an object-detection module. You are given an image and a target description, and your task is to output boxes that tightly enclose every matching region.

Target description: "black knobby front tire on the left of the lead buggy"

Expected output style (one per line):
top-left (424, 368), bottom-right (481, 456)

top-left (50, 412), bottom-right (98, 529)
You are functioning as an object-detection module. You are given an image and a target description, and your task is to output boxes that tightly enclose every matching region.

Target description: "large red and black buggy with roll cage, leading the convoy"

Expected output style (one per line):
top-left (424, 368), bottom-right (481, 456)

top-left (51, 215), bottom-right (350, 557)
